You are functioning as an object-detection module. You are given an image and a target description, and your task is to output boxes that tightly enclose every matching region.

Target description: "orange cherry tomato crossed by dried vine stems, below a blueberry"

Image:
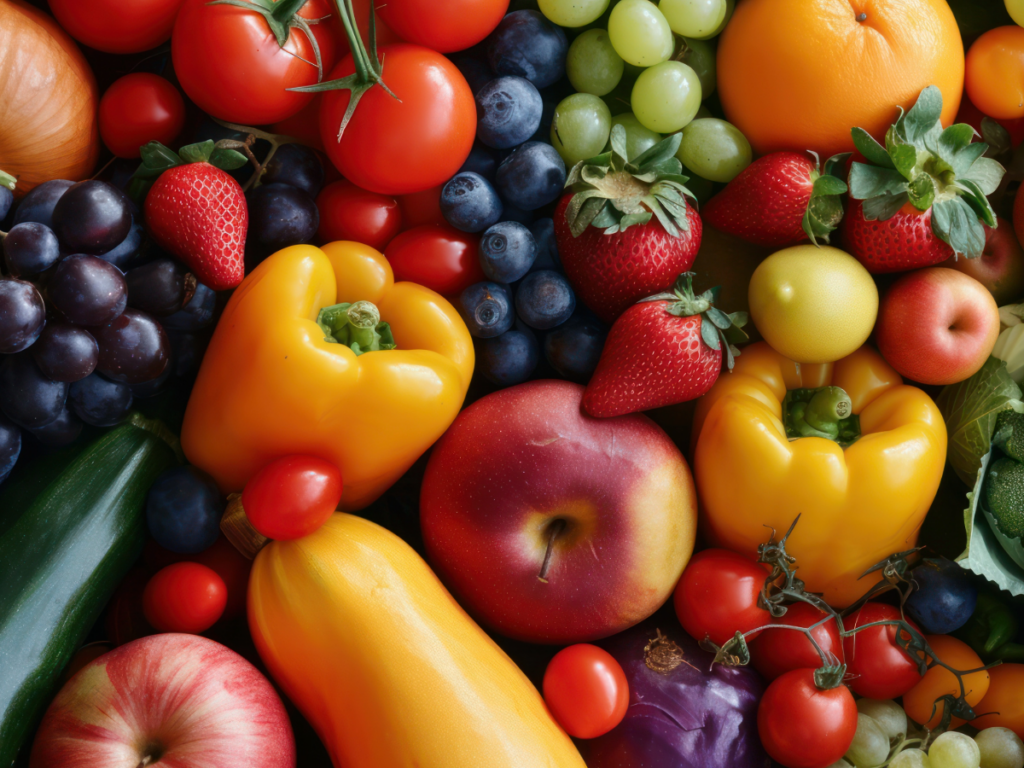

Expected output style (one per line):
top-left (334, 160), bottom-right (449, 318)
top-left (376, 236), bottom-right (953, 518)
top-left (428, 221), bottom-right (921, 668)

top-left (903, 635), bottom-right (987, 728)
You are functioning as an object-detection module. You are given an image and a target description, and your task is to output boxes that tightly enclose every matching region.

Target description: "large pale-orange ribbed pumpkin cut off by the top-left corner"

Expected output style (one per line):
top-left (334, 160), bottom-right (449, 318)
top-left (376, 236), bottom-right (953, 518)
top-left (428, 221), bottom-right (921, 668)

top-left (0, 0), bottom-right (99, 198)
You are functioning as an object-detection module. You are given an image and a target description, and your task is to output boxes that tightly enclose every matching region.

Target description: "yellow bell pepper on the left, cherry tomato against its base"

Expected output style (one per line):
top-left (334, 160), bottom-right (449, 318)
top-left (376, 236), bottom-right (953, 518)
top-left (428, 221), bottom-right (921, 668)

top-left (181, 242), bottom-right (474, 510)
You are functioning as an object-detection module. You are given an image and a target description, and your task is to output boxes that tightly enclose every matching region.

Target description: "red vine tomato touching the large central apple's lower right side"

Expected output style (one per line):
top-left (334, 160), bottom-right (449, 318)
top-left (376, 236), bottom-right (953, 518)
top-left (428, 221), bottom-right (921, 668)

top-left (675, 549), bottom-right (771, 645)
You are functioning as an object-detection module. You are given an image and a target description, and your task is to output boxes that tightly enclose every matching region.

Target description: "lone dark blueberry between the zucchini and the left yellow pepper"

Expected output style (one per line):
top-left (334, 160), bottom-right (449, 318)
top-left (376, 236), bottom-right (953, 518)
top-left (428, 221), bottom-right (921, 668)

top-left (145, 466), bottom-right (224, 555)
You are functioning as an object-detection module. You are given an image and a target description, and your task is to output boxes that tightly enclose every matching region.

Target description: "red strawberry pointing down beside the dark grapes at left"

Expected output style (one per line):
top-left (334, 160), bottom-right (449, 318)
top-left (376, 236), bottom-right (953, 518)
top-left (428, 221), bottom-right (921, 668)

top-left (129, 141), bottom-right (249, 291)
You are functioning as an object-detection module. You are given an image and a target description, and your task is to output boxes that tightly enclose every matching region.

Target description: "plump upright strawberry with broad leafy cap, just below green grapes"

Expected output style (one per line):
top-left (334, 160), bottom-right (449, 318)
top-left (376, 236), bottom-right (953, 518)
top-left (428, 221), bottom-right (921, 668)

top-left (554, 126), bottom-right (701, 323)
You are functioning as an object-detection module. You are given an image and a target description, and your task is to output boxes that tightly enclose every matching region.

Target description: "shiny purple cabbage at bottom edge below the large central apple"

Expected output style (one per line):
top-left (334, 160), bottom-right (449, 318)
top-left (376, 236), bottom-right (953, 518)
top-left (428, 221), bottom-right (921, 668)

top-left (584, 613), bottom-right (771, 768)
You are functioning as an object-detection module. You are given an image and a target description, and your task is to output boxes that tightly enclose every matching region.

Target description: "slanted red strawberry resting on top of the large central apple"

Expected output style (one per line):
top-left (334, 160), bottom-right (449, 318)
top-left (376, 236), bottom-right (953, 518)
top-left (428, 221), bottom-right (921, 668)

top-left (583, 272), bottom-right (746, 418)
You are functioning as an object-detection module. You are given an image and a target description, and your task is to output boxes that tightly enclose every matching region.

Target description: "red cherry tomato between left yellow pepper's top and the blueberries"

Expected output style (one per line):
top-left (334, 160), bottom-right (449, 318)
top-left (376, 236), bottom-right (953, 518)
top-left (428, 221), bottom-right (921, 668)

top-left (384, 224), bottom-right (486, 296)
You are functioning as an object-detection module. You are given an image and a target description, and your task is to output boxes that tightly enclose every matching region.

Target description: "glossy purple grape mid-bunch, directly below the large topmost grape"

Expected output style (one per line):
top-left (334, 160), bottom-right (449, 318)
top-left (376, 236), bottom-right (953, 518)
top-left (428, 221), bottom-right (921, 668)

top-left (47, 253), bottom-right (128, 326)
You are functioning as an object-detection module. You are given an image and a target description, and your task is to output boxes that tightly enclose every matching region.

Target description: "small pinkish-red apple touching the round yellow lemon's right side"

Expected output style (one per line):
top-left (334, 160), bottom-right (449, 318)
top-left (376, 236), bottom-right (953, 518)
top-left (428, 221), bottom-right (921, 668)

top-left (874, 266), bottom-right (999, 384)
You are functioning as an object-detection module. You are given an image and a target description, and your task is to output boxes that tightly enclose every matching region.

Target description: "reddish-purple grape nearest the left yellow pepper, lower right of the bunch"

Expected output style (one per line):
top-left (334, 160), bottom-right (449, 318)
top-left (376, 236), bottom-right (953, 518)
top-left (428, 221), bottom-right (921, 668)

top-left (92, 309), bottom-right (171, 384)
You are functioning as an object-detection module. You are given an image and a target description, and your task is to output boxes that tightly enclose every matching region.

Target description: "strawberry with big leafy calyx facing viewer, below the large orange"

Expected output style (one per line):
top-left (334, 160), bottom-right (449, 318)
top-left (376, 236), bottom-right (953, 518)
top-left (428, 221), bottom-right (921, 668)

top-left (843, 85), bottom-right (1006, 273)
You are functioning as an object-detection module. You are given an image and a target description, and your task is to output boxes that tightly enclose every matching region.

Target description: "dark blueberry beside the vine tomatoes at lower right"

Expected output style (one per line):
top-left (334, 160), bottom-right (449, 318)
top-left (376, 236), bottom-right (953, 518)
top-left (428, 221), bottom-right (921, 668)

top-left (906, 558), bottom-right (978, 635)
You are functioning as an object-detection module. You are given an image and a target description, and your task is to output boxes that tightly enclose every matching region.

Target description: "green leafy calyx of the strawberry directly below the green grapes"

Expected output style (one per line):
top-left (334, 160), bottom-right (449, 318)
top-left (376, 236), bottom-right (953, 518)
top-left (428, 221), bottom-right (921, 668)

top-left (565, 125), bottom-right (696, 238)
